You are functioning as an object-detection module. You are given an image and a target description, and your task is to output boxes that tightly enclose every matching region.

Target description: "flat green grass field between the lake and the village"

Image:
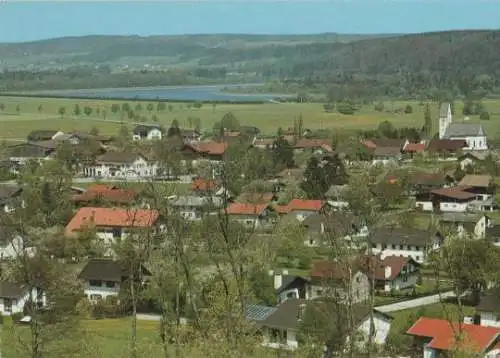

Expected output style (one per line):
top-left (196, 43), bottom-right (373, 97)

top-left (0, 97), bottom-right (500, 140)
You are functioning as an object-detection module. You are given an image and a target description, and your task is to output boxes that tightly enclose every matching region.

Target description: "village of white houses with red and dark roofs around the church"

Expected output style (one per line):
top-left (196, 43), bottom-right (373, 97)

top-left (0, 103), bottom-right (500, 357)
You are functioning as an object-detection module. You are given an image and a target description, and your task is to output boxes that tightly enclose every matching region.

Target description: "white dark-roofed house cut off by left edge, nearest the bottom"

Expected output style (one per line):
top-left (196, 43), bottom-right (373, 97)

top-left (0, 281), bottom-right (47, 316)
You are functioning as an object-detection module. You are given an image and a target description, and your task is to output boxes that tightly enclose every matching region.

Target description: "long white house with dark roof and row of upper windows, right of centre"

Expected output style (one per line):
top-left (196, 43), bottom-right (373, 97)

top-left (370, 227), bottom-right (443, 264)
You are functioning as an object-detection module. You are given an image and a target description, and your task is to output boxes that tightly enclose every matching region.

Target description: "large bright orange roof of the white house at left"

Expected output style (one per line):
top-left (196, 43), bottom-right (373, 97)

top-left (65, 207), bottom-right (159, 234)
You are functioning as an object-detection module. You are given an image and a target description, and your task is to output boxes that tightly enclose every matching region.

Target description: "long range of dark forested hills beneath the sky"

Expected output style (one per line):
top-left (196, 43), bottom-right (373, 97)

top-left (0, 30), bottom-right (500, 98)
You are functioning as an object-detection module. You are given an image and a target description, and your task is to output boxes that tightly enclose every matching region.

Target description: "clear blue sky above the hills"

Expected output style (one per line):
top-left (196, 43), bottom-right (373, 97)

top-left (0, 0), bottom-right (500, 42)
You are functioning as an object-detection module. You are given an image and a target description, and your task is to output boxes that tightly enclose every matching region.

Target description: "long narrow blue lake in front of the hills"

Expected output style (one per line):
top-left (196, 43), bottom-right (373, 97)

top-left (32, 84), bottom-right (291, 102)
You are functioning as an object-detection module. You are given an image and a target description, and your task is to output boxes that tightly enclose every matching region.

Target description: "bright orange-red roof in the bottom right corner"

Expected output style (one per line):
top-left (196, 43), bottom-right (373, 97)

top-left (406, 317), bottom-right (500, 352)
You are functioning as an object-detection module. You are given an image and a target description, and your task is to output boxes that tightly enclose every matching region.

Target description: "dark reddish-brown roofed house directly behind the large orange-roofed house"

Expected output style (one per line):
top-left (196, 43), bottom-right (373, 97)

top-left (72, 184), bottom-right (137, 206)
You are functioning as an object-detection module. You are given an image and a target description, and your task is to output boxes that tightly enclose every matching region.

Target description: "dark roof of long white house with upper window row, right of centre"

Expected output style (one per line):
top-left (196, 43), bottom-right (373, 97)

top-left (370, 228), bottom-right (437, 246)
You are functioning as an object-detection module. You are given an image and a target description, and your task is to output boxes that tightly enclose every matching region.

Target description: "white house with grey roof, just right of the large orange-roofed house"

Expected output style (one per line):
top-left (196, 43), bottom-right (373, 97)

top-left (171, 195), bottom-right (224, 221)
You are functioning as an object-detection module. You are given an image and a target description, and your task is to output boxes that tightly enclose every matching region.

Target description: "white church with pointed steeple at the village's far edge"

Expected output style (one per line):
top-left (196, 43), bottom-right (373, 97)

top-left (439, 103), bottom-right (488, 150)
